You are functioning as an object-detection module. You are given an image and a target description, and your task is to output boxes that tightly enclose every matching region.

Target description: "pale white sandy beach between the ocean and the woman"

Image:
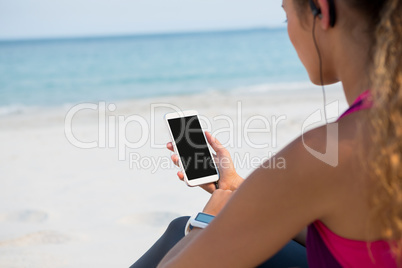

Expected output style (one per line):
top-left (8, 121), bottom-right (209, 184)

top-left (0, 83), bottom-right (347, 267)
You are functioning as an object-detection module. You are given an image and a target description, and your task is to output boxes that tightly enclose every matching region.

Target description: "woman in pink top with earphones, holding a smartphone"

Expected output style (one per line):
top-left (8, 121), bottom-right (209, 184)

top-left (133, 0), bottom-right (402, 267)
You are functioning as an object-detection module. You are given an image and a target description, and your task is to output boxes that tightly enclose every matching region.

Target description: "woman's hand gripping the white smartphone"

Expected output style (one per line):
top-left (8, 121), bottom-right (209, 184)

top-left (166, 132), bottom-right (244, 193)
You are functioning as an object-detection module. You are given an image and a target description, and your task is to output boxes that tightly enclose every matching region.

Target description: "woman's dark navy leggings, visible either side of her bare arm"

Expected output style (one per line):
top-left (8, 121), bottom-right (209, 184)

top-left (130, 217), bottom-right (308, 268)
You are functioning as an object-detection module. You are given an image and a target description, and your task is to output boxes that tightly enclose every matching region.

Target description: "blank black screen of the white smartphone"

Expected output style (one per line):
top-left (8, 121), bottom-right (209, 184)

top-left (168, 115), bottom-right (218, 180)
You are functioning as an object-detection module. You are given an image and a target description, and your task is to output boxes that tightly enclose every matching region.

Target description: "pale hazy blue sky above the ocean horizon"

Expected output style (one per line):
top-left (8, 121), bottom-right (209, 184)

top-left (0, 0), bottom-right (285, 40)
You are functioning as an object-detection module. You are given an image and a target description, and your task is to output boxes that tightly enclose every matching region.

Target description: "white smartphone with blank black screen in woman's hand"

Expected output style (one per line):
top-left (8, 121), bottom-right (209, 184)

top-left (165, 111), bottom-right (219, 186)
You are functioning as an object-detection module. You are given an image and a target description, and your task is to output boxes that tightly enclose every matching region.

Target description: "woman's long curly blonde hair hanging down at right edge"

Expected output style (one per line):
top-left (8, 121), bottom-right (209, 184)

top-left (369, 0), bottom-right (402, 265)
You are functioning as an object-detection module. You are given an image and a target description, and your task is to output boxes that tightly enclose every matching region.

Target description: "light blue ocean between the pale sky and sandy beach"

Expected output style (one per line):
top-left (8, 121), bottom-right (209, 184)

top-left (0, 28), bottom-right (309, 115)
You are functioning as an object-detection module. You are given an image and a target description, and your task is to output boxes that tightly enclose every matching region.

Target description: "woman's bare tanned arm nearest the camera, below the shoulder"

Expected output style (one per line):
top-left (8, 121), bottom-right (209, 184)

top-left (160, 124), bottom-right (339, 267)
